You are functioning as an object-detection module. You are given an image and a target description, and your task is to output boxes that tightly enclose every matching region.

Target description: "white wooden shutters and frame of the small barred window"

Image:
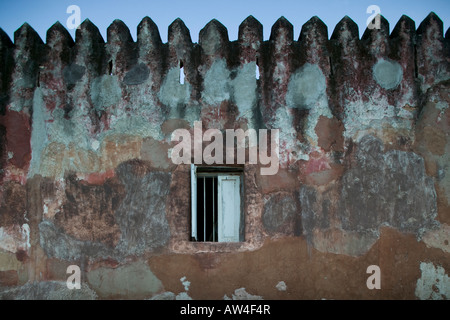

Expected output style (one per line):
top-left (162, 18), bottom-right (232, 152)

top-left (191, 164), bottom-right (242, 243)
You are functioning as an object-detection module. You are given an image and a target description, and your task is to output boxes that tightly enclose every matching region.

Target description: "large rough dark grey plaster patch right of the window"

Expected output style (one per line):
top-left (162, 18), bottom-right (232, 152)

top-left (340, 136), bottom-right (437, 237)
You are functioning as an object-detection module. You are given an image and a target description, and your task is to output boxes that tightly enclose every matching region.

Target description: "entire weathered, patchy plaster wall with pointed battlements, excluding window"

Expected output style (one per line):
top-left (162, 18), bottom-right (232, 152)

top-left (0, 13), bottom-right (450, 299)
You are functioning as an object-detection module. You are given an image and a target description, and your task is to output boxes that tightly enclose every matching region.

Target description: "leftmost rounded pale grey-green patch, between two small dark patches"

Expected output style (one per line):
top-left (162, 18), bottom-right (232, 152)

top-left (91, 75), bottom-right (122, 111)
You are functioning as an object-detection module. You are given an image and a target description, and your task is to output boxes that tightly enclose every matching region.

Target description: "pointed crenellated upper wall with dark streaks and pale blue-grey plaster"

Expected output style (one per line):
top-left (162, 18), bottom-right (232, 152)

top-left (0, 13), bottom-right (450, 178)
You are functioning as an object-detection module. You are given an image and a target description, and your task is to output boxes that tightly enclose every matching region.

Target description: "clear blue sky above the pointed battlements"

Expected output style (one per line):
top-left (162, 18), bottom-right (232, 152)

top-left (0, 0), bottom-right (450, 42)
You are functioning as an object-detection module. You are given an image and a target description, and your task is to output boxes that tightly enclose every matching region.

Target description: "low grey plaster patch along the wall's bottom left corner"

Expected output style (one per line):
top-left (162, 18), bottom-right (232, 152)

top-left (0, 281), bottom-right (97, 300)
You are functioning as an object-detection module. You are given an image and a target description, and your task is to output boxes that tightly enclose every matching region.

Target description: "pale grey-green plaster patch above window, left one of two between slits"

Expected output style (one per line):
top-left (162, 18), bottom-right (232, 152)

top-left (202, 59), bottom-right (231, 105)
